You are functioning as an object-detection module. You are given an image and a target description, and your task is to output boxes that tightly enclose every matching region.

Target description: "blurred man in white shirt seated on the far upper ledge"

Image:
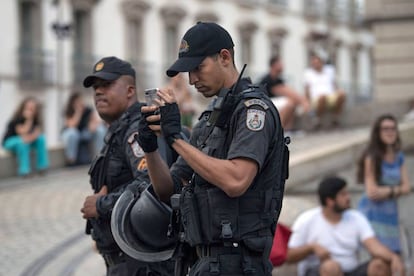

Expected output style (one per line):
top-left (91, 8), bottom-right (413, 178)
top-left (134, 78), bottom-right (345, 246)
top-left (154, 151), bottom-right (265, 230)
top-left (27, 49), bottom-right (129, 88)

top-left (304, 54), bottom-right (346, 128)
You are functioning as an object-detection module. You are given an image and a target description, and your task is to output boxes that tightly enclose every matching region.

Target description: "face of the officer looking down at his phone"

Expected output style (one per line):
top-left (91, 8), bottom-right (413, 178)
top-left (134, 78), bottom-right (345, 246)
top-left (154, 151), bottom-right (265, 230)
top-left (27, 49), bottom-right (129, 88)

top-left (188, 55), bottom-right (224, 98)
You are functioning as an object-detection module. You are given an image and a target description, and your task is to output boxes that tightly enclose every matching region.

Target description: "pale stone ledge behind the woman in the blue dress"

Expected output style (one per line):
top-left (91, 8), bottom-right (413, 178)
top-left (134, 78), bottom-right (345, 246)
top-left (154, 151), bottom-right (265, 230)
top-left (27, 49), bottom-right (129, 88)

top-left (286, 121), bottom-right (414, 191)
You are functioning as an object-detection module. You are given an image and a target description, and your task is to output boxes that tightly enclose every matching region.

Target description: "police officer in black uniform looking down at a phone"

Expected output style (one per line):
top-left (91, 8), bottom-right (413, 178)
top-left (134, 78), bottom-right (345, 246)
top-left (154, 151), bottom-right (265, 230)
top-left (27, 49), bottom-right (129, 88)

top-left (138, 22), bottom-right (288, 275)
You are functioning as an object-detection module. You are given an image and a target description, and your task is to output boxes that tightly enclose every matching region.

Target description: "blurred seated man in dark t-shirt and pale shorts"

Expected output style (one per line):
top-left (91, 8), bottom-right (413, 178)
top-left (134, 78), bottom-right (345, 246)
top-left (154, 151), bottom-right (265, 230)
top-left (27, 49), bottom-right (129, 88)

top-left (260, 56), bottom-right (310, 131)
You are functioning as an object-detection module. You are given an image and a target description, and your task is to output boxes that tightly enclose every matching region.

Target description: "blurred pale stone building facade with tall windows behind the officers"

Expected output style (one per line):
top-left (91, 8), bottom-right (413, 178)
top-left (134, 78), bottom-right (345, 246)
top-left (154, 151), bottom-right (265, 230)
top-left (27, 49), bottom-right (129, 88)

top-left (0, 0), bottom-right (376, 145)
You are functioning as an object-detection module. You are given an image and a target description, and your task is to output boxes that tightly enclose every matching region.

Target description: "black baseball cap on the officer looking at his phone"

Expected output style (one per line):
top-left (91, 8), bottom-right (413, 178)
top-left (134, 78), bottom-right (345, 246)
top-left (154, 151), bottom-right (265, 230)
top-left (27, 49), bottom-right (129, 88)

top-left (167, 22), bottom-right (234, 77)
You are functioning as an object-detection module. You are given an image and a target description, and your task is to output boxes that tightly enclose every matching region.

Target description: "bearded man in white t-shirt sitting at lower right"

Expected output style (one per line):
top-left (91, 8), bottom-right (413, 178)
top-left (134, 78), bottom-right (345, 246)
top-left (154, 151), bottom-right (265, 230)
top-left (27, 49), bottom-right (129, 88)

top-left (287, 177), bottom-right (404, 276)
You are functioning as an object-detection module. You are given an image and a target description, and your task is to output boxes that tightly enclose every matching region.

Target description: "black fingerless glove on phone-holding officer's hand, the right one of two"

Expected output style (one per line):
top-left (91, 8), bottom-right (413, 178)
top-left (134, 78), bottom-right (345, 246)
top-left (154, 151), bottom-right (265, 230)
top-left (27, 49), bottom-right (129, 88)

top-left (160, 103), bottom-right (181, 146)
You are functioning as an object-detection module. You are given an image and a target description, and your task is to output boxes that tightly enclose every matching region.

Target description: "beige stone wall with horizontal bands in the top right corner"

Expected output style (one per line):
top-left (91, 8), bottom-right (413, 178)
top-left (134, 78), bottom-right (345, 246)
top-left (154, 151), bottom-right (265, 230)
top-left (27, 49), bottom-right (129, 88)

top-left (366, 0), bottom-right (414, 101)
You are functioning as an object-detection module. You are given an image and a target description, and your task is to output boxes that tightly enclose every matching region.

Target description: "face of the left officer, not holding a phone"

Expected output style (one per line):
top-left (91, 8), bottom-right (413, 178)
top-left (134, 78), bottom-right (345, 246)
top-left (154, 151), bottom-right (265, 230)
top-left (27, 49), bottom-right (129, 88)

top-left (93, 76), bottom-right (129, 123)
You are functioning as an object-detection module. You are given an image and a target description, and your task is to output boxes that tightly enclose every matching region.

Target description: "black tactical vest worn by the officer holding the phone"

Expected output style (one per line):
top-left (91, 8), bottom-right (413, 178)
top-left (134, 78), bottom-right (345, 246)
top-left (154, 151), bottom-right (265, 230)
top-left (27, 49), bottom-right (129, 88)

top-left (182, 78), bottom-right (288, 247)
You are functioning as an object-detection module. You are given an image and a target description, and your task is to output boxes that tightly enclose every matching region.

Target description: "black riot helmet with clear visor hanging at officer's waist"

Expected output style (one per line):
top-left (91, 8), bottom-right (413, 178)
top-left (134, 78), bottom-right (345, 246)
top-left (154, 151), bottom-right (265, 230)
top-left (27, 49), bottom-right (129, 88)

top-left (111, 186), bottom-right (176, 262)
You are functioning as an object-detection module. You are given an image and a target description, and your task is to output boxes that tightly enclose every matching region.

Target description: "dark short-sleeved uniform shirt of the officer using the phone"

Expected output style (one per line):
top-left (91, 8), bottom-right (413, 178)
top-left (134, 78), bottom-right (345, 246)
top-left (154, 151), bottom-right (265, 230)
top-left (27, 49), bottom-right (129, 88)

top-left (171, 78), bottom-right (278, 192)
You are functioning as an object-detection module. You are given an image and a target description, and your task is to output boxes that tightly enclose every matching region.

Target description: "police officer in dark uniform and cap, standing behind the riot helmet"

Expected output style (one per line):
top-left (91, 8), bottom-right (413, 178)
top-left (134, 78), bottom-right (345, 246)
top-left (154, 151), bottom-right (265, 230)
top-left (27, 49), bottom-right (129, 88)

top-left (81, 57), bottom-right (174, 276)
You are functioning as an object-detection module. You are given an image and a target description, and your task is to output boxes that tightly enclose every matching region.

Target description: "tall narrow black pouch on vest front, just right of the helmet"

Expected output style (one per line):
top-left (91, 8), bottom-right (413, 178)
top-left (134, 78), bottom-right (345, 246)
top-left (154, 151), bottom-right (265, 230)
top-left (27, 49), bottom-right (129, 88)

top-left (181, 187), bottom-right (203, 246)
